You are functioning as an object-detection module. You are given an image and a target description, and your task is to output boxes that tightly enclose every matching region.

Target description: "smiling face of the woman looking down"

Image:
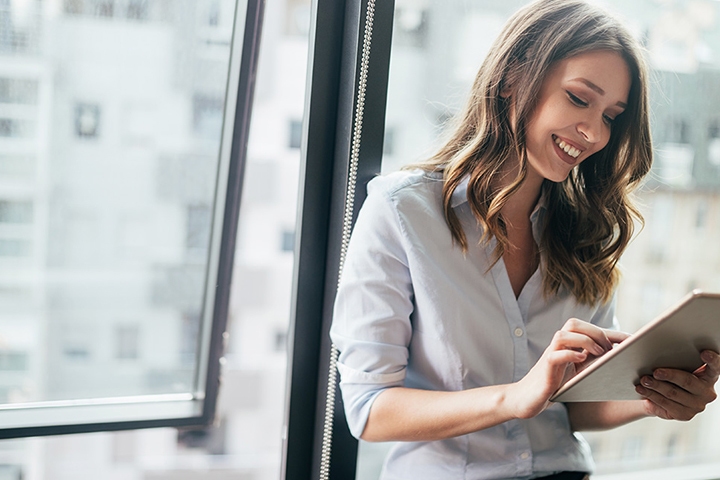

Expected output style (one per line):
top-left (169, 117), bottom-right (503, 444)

top-left (526, 50), bottom-right (630, 182)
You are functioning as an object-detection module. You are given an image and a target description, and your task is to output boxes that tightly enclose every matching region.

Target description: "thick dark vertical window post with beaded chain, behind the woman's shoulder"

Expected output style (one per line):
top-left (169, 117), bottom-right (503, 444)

top-left (281, 0), bottom-right (395, 480)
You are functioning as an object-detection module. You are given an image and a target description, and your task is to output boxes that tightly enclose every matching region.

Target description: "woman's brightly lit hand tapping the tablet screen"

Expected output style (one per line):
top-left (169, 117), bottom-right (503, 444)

top-left (508, 318), bottom-right (630, 418)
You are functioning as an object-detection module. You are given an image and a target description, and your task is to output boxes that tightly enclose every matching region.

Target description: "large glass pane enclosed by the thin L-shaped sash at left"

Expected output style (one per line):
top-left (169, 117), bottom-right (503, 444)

top-left (0, 0), bottom-right (236, 412)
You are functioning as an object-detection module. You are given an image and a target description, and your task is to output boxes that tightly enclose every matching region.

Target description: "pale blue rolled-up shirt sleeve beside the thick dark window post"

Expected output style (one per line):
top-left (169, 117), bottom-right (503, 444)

top-left (330, 178), bottom-right (413, 438)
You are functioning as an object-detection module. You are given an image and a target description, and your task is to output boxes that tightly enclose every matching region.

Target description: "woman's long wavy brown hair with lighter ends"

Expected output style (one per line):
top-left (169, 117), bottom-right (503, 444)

top-left (421, 0), bottom-right (652, 304)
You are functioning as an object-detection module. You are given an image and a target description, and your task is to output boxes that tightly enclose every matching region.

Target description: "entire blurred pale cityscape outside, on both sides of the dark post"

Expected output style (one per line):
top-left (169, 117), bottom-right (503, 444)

top-left (0, 0), bottom-right (720, 480)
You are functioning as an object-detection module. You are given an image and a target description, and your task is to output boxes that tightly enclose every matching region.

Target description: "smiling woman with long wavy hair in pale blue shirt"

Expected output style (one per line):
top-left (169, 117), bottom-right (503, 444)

top-left (331, 0), bottom-right (720, 480)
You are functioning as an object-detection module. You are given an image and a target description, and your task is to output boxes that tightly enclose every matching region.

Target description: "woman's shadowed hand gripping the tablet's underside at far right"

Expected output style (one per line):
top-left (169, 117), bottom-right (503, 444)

top-left (635, 350), bottom-right (720, 420)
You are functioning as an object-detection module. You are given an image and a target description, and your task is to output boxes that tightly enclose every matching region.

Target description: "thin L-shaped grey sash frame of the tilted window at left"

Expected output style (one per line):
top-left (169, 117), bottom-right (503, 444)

top-left (0, 0), bottom-right (265, 439)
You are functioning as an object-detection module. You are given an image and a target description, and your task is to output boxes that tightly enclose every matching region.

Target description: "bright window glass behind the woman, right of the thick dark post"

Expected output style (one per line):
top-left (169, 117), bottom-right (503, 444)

top-left (358, 0), bottom-right (720, 480)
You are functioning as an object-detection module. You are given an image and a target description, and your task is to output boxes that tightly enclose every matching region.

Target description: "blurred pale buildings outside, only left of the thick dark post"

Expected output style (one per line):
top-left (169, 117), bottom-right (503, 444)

top-left (0, 0), bottom-right (310, 480)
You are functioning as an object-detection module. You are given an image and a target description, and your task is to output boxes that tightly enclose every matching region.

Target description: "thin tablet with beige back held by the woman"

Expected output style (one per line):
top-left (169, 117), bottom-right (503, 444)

top-left (550, 290), bottom-right (720, 402)
